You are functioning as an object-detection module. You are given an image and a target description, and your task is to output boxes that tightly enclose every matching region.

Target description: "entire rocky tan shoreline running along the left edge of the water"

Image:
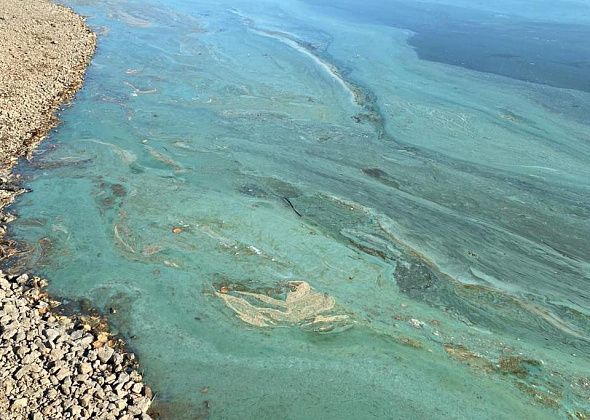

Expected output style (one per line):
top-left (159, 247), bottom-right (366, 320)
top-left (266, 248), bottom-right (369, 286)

top-left (0, 0), bottom-right (153, 419)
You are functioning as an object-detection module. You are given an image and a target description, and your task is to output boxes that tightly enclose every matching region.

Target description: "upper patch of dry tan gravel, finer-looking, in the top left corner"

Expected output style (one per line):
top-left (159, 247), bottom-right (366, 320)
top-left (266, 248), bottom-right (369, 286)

top-left (0, 0), bottom-right (96, 166)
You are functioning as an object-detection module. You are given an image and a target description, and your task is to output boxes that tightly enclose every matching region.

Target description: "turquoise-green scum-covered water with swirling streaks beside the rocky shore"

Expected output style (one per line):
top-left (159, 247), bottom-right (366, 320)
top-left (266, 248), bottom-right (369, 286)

top-left (12, 0), bottom-right (590, 419)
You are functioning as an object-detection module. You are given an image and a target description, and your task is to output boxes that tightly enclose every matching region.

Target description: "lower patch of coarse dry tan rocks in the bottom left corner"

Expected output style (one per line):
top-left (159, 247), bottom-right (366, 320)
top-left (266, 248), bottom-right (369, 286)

top-left (0, 272), bottom-right (152, 419)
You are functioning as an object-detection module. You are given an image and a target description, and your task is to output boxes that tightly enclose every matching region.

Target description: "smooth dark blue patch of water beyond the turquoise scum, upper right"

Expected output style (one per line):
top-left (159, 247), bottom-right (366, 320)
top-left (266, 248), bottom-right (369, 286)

top-left (307, 0), bottom-right (590, 92)
